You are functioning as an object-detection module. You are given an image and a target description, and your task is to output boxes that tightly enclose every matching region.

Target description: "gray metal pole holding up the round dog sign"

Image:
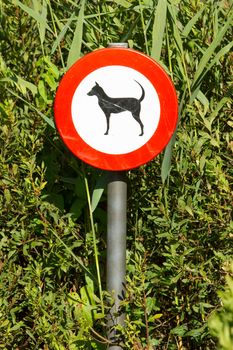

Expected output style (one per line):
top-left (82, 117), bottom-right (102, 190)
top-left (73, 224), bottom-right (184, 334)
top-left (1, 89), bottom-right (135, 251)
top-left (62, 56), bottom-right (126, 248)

top-left (107, 43), bottom-right (128, 350)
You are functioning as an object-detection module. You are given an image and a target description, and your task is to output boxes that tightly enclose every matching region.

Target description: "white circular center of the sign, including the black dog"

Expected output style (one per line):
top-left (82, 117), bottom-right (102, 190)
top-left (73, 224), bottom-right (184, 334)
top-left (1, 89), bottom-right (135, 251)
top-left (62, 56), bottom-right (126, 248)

top-left (71, 66), bottom-right (160, 154)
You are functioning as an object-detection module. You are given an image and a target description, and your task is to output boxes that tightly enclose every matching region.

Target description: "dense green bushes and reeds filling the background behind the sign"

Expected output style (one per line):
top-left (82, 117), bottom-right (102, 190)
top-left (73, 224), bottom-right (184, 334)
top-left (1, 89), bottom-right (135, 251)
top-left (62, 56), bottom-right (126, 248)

top-left (0, 0), bottom-right (233, 350)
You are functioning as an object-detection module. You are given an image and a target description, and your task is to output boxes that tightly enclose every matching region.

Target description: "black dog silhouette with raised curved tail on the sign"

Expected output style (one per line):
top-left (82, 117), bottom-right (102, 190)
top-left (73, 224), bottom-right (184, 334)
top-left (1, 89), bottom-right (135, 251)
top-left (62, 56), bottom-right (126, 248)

top-left (87, 80), bottom-right (145, 136)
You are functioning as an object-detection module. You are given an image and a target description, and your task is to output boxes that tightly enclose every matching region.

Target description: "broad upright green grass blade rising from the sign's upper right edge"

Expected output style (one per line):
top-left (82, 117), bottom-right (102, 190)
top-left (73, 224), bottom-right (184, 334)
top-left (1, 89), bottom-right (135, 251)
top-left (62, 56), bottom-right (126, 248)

top-left (151, 0), bottom-right (167, 60)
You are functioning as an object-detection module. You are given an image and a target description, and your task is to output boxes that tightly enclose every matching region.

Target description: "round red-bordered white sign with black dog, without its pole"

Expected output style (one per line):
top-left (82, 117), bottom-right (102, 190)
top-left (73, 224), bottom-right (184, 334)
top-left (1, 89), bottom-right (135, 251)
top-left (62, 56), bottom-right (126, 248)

top-left (54, 48), bottom-right (178, 171)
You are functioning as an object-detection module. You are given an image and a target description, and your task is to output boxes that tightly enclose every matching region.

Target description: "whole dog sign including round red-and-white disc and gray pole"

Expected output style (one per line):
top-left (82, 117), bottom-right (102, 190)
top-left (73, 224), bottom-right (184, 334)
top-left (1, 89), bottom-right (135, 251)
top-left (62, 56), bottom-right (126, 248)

top-left (54, 43), bottom-right (178, 350)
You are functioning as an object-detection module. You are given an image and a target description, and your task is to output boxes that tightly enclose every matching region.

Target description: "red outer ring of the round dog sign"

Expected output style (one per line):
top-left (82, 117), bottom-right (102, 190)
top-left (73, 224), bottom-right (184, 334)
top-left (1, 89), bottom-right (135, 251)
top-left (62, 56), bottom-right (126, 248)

top-left (54, 48), bottom-right (178, 171)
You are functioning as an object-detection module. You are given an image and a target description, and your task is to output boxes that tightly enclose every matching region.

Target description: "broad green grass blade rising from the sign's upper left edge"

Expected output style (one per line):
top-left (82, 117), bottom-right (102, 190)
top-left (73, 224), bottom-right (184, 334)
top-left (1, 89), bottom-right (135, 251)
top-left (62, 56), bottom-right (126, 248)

top-left (67, 0), bottom-right (86, 69)
